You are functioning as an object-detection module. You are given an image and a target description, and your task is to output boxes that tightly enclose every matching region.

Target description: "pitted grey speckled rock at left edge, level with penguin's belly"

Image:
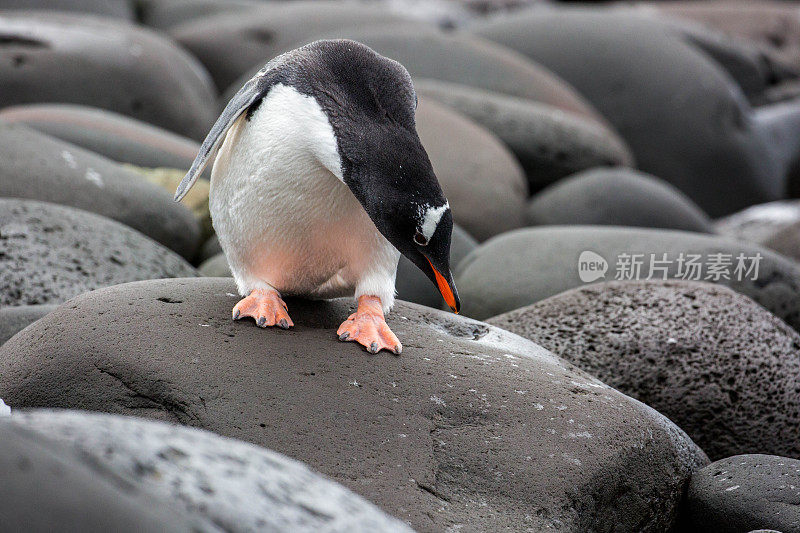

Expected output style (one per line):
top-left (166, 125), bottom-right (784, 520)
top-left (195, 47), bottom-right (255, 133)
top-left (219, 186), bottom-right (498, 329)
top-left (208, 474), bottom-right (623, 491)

top-left (0, 198), bottom-right (195, 308)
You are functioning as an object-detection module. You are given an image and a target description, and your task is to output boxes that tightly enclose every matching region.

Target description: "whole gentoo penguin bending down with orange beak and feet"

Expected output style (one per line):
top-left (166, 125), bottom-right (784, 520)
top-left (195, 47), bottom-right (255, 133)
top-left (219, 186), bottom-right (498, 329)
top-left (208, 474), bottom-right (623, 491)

top-left (175, 40), bottom-right (460, 354)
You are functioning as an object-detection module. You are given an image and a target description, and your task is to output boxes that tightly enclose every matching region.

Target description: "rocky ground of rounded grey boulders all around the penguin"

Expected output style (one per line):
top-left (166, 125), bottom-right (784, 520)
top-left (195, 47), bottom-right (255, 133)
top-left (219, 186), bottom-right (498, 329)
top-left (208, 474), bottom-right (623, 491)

top-left (0, 0), bottom-right (800, 533)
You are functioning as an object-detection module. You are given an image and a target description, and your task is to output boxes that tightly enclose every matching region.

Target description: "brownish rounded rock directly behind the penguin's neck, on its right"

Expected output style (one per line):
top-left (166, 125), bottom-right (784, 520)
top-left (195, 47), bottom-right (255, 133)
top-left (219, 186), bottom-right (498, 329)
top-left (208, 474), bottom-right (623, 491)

top-left (416, 98), bottom-right (528, 241)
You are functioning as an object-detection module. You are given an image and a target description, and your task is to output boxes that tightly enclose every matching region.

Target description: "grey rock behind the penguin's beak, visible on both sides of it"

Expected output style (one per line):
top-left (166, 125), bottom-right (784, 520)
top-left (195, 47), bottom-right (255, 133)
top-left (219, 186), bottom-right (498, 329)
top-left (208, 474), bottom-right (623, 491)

top-left (395, 225), bottom-right (478, 309)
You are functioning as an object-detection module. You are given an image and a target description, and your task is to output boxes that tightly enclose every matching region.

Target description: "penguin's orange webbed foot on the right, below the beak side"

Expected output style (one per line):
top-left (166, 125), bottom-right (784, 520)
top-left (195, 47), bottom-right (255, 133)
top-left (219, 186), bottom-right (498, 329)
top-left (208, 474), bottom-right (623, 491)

top-left (336, 295), bottom-right (403, 355)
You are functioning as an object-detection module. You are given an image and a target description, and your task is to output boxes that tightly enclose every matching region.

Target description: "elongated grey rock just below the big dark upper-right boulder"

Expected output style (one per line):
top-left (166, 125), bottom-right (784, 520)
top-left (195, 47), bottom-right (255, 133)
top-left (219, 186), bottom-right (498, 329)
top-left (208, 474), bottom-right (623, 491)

top-left (414, 79), bottom-right (633, 191)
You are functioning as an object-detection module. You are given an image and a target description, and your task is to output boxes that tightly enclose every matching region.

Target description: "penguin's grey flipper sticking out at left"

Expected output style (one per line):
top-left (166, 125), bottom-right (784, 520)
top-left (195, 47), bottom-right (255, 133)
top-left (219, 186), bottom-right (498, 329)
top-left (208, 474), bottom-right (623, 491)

top-left (175, 54), bottom-right (288, 202)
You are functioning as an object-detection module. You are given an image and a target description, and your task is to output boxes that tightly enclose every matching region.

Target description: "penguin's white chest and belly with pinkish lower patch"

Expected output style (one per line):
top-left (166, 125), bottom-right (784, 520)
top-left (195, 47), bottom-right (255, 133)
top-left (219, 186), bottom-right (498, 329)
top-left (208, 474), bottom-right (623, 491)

top-left (210, 85), bottom-right (397, 297)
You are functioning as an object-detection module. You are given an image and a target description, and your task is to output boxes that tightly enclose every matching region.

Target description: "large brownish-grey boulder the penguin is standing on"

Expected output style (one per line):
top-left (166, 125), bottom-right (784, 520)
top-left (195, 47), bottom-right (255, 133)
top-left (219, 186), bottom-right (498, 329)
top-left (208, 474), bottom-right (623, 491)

top-left (0, 278), bottom-right (706, 532)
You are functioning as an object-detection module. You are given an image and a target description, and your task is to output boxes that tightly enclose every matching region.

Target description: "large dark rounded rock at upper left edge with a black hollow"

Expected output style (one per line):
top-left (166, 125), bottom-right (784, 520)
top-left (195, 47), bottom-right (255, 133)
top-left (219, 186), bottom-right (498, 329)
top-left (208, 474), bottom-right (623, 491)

top-left (0, 11), bottom-right (216, 139)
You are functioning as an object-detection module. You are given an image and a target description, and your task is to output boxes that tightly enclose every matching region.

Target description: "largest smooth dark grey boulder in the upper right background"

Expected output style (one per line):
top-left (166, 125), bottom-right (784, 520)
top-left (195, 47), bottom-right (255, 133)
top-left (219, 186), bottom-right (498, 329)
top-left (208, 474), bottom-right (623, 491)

top-left (476, 9), bottom-right (786, 216)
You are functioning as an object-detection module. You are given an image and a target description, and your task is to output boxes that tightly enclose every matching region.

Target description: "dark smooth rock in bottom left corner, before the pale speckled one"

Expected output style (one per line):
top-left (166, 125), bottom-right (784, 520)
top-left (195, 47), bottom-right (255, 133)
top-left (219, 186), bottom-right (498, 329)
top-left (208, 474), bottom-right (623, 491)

top-left (0, 416), bottom-right (194, 533)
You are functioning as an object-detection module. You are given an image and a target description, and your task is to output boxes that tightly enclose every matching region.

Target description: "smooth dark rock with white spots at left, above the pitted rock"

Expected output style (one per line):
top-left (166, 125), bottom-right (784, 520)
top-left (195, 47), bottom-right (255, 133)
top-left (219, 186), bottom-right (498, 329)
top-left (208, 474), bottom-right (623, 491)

top-left (0, 122), bottom-right (200, 257)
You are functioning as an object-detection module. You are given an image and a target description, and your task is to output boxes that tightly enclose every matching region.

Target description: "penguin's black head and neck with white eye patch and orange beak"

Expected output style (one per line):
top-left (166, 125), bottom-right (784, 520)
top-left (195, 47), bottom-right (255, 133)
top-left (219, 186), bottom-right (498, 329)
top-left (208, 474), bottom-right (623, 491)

top-left (303, 40), bottom-right (460, 313)
